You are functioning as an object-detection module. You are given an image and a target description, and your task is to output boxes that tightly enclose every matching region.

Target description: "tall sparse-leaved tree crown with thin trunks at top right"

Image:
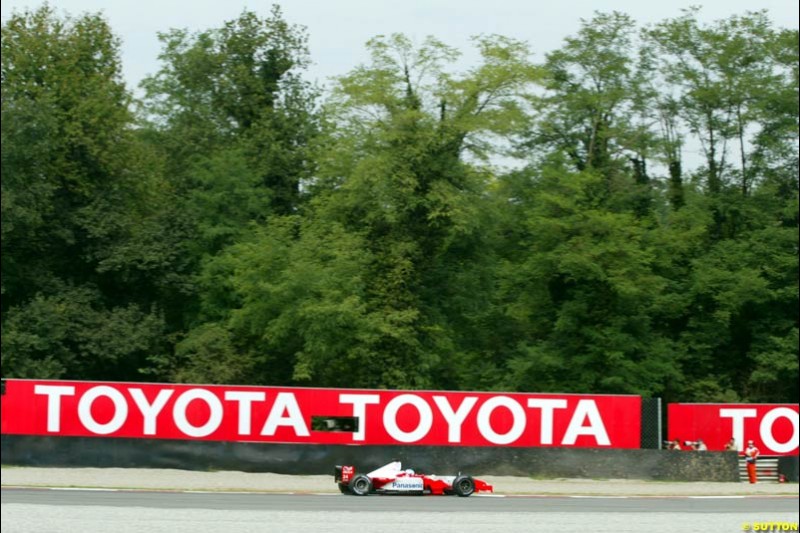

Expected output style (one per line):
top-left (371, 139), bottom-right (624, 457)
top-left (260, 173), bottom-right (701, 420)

top-left (647, 8), bottom-right (780, 200)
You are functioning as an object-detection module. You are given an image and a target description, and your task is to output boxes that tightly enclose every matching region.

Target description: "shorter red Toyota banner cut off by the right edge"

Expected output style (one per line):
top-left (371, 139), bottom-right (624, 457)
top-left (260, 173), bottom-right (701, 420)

top-left (667, 403), bottom-right (800, 455)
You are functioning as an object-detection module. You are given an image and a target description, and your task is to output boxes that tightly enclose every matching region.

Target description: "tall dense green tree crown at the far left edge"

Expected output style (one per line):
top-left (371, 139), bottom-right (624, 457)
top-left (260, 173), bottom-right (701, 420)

top-left (2, 6), bottom-right (136, 298)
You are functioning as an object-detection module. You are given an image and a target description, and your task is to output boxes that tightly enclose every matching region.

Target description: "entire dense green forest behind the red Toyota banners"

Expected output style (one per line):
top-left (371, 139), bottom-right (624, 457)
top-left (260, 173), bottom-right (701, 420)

top-left (2, 5), bottom-right (800, 402)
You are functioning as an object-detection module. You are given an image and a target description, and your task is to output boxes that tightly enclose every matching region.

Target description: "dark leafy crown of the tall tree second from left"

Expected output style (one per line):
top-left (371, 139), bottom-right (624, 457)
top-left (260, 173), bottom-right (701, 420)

top-left (142, 6), bottom-right (316, 215)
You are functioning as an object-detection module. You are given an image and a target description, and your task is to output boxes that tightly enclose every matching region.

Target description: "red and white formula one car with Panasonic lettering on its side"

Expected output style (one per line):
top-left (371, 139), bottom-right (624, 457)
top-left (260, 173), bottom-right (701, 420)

top-left (333, 461), bottom-right (494, 497)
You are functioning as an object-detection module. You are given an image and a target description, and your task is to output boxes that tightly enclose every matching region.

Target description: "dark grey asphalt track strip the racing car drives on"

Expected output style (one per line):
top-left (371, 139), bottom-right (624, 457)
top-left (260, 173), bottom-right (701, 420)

top-left (2, 488), bottom-right (798, 513)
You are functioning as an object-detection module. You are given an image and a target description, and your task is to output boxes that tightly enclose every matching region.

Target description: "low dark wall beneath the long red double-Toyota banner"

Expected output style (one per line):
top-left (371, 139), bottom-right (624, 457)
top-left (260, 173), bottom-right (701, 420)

top-left (2, 435), bottom-right (739, 481)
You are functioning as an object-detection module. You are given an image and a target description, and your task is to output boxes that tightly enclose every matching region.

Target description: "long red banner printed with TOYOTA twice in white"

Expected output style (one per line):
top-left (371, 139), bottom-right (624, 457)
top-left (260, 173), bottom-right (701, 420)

top-left (2, 379), bottom-right (641, 448)
